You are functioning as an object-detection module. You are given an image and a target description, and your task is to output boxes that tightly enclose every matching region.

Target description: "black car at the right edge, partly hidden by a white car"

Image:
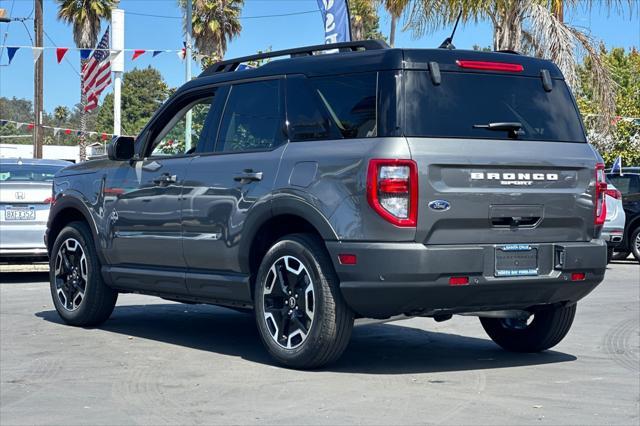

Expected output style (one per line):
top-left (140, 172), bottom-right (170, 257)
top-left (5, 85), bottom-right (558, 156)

top-left (607, 167), bottom-right (640, 262)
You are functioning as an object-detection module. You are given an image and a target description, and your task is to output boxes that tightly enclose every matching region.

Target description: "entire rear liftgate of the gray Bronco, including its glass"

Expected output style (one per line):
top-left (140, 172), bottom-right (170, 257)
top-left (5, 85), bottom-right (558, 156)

top-left (404, 66), bottom-right (595, 244)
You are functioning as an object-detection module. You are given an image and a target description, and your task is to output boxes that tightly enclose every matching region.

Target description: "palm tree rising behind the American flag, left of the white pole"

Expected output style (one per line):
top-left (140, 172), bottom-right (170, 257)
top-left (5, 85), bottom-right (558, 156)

top-left (56, 0), bottom-right (114, 161)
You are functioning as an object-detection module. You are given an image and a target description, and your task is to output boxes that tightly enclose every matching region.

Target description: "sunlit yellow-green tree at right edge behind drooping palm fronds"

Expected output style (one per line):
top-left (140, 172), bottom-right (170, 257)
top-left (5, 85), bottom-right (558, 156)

top-left (576, 46), bottom-right (640, 165)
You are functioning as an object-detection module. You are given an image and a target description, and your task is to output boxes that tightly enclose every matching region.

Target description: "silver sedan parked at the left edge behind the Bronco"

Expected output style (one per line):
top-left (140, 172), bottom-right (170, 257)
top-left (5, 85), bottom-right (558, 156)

top-left (0, 158), bottom-right (72, 262)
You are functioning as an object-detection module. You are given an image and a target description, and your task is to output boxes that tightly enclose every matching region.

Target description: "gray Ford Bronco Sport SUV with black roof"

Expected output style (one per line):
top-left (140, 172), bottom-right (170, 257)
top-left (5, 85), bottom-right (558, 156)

top-left (47, 41), bottom-right (607, 368)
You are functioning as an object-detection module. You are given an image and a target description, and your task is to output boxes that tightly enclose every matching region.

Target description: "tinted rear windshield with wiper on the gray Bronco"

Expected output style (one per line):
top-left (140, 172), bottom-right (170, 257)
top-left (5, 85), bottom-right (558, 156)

top-left (405, 71), bottom-right (586, 142)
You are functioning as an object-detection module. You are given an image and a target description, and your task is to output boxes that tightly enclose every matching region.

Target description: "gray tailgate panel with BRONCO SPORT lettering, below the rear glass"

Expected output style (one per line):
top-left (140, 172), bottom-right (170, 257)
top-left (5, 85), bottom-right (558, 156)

top-left (408, 138), bottom-right (595, 244)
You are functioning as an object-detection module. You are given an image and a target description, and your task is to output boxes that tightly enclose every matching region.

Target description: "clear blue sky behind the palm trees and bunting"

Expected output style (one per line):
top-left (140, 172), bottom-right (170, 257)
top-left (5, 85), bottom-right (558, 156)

top-left (0, 0), bottom-right (640, 111)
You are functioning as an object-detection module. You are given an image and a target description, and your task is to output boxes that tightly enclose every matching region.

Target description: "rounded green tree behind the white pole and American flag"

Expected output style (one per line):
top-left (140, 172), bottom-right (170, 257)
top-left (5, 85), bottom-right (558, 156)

top-left (96, 67), bottom-right (170, 135)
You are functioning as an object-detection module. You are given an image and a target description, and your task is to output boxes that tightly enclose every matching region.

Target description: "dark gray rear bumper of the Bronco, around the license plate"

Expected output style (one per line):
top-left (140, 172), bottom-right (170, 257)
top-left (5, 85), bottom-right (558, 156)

top-left (327, 240), bottom-right (607, 318)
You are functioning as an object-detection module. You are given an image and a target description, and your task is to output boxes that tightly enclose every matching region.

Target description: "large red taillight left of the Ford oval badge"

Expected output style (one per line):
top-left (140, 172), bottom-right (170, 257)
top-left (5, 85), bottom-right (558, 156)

top-left (367, 159), bottom-right (418, 227)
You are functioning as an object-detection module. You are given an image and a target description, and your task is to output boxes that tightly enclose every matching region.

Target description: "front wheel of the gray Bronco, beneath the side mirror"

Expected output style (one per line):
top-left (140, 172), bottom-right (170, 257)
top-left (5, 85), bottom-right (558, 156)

top-left (49, 222), bottom-right (118, 327)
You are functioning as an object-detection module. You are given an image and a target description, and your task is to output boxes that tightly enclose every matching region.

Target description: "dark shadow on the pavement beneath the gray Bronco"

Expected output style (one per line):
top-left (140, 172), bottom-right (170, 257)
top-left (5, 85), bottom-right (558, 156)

top-left (36, 304), bottom-right (576, 374)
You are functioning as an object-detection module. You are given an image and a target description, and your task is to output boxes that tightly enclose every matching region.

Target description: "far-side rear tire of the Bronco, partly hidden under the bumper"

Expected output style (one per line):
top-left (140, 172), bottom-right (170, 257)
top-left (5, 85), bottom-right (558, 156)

top-left (480, 304), bottom-right (576, 352)
